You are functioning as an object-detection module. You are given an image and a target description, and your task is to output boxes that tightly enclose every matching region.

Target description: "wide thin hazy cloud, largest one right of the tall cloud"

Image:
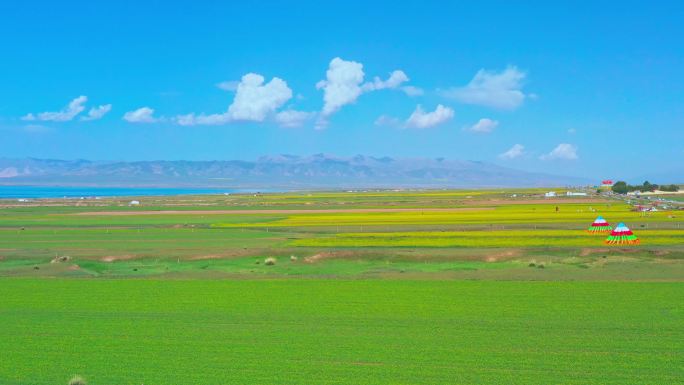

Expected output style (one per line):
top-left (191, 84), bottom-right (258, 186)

top-left (441, 66), bottom-right (526, 110)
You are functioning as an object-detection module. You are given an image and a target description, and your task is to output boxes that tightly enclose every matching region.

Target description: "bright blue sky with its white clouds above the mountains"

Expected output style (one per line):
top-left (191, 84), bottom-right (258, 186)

top-left (0, 1), bottom-right (684, 178)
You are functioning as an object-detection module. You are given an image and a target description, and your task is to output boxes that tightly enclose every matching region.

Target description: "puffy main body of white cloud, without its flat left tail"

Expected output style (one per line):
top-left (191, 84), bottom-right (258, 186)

top-left (228, 73), bottom-right (292, 122)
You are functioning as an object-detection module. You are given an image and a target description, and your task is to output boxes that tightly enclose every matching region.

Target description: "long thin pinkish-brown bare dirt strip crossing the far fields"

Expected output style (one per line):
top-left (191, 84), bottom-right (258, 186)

top-left (70, 207), bottom-right (494, 216)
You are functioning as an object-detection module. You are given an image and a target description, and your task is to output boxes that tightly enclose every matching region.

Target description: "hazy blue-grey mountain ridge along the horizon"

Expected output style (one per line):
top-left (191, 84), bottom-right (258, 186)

top-left (0, 154), bottom-right (591, 189)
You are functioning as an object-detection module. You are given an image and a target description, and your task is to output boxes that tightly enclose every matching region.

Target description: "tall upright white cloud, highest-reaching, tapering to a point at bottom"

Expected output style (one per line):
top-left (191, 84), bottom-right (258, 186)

top-left (316, 57), bottom-right (364, 118)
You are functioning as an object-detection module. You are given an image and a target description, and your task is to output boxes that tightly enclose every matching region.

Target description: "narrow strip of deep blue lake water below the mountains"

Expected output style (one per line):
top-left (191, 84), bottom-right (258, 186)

top-left (0, 186), bottom-right (265, 199)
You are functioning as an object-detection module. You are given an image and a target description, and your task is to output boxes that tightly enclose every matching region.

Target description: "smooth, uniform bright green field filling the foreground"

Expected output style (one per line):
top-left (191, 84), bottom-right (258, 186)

top-left (0, 279), bottom-right (684, 385)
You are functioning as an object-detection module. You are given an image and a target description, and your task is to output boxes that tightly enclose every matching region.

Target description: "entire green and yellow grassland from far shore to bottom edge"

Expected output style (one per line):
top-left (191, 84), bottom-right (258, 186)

top-left (0, 189), bottom-right (684, 385)
